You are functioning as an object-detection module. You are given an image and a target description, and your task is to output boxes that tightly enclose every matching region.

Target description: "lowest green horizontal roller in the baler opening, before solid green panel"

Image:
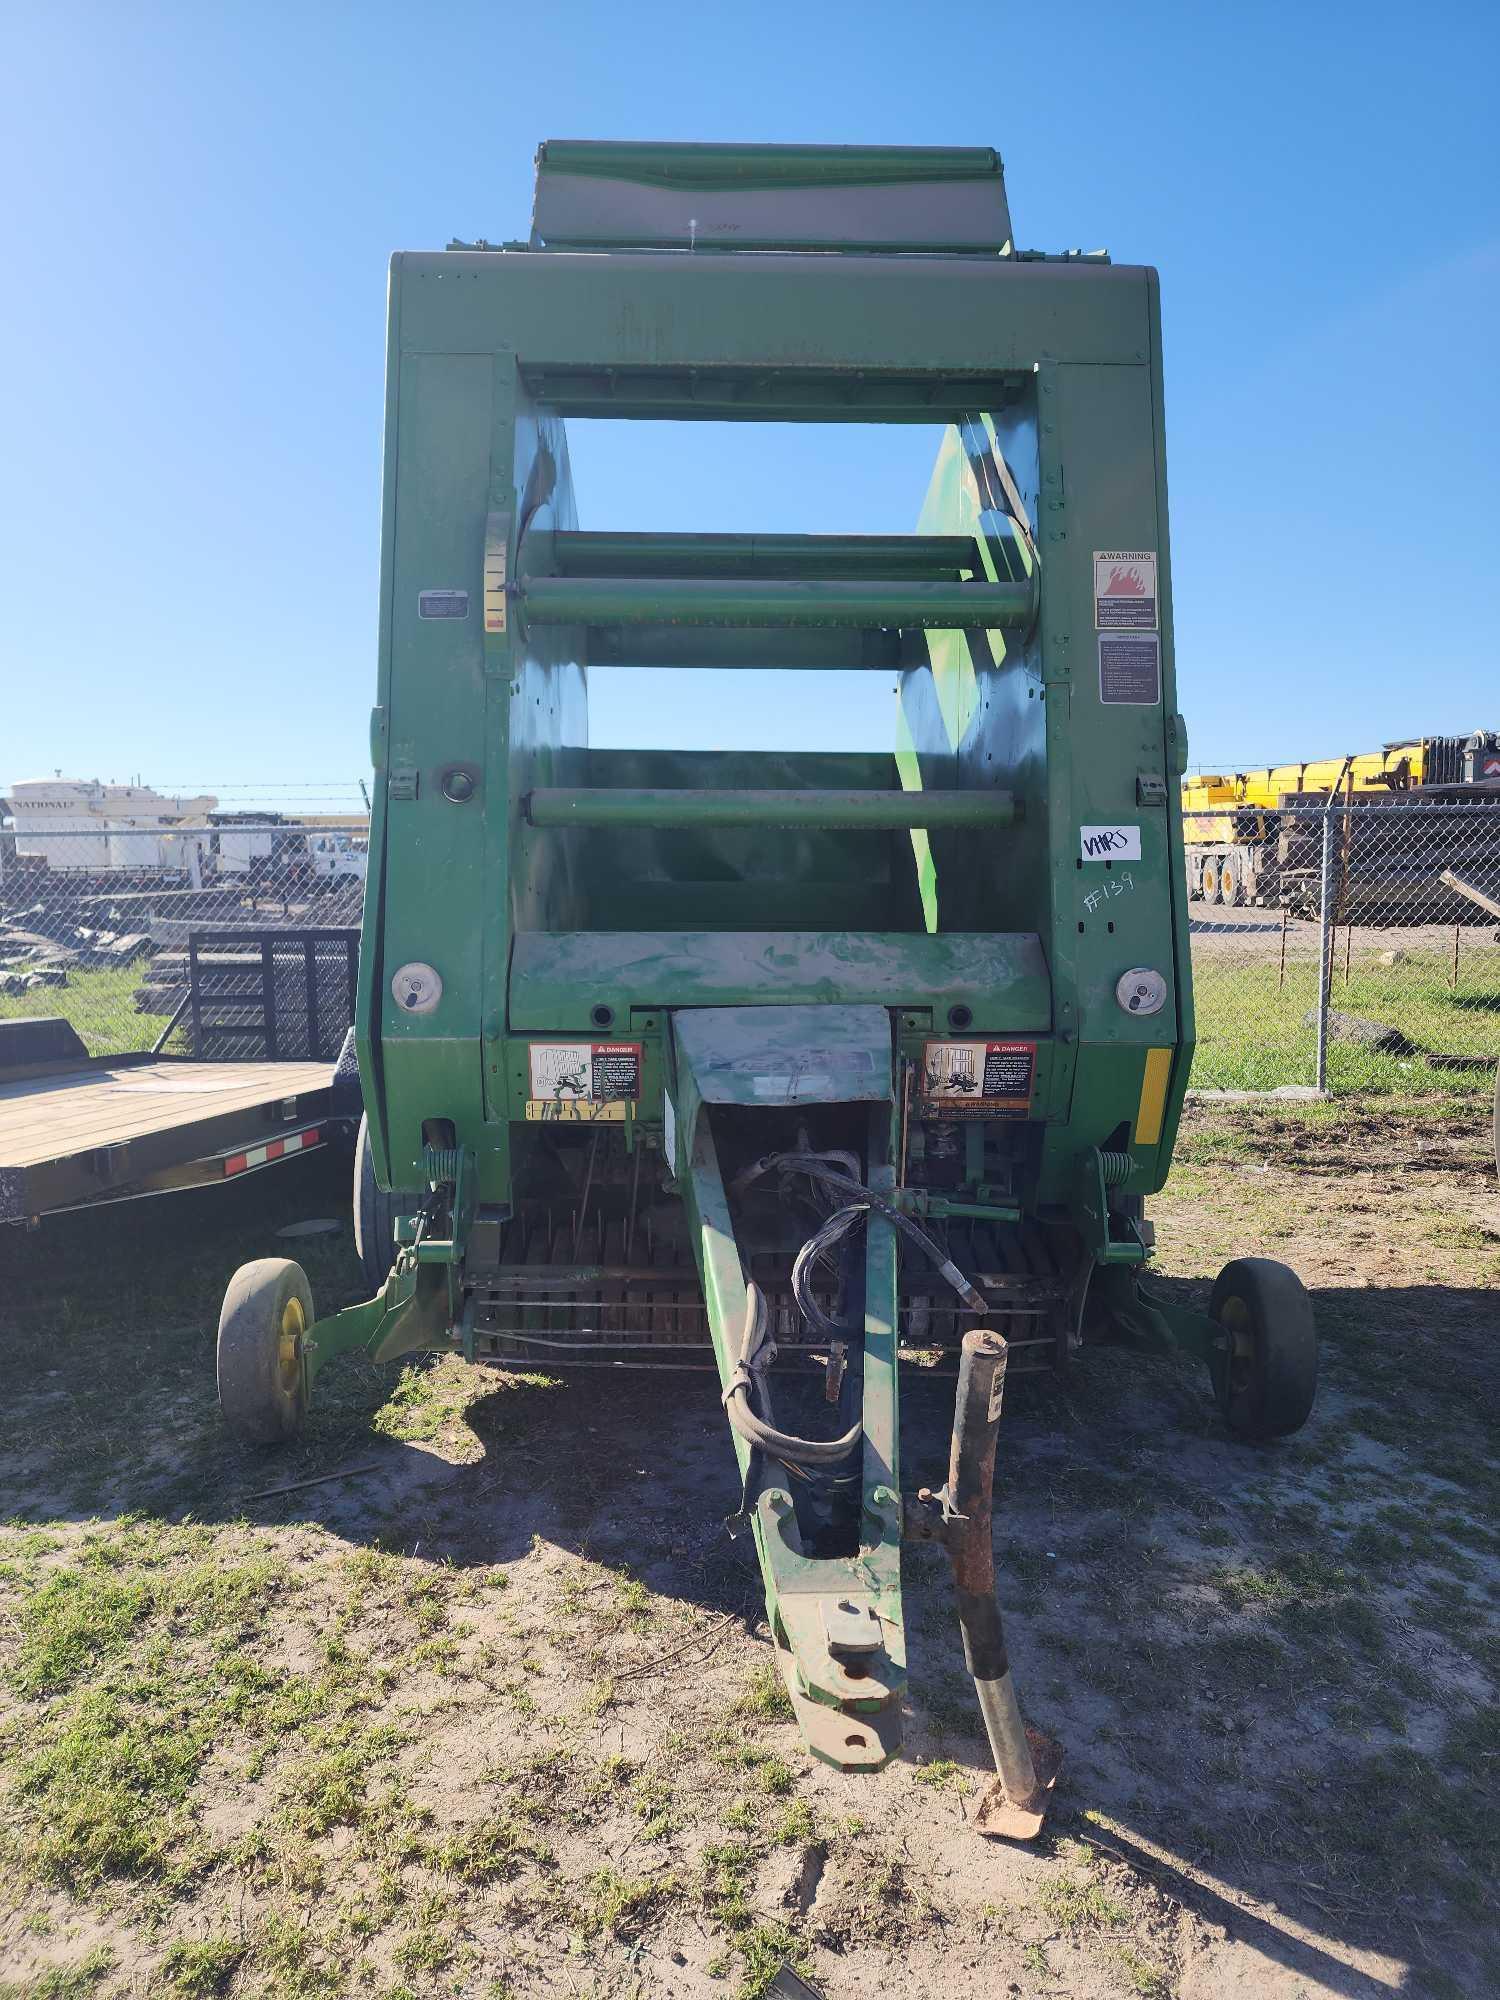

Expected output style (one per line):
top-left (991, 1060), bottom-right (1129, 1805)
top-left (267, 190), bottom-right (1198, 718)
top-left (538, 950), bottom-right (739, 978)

top-left (526, 786), bottom-right (1020, 830)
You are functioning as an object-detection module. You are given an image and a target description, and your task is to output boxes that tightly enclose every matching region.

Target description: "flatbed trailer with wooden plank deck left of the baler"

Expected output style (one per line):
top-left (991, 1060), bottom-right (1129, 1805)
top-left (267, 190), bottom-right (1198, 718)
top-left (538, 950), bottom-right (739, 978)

top-left (0, 1018), bottom-right (344, 1224)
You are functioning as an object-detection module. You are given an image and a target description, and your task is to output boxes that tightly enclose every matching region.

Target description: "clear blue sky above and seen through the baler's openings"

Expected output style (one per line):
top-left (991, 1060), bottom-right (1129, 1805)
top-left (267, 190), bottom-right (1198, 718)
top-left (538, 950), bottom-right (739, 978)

top-left (0, 0), bottom-right (1500, 804)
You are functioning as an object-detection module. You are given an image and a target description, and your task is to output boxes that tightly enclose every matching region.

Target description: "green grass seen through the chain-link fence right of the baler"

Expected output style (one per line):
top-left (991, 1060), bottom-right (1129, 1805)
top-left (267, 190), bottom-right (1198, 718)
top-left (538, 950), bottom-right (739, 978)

top-left (1192, 930), bottom-right (1500, 1098)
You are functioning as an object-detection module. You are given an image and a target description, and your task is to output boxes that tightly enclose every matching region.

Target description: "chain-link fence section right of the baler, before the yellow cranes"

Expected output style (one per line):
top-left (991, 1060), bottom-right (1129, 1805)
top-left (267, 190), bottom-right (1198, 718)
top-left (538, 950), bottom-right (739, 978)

top-left (1184, 794), bottom-right (1500, 1094)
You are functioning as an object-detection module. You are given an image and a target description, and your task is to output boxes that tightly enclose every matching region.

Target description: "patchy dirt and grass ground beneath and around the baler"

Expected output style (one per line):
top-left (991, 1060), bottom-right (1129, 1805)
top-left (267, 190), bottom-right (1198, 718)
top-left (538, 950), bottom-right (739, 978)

top-left (0, 1100), bottom-right (1500, 2000)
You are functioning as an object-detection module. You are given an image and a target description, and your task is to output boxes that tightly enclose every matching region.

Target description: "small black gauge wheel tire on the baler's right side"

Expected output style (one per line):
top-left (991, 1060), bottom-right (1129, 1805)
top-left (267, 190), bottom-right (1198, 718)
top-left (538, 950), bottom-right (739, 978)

top-left (1208, 1256), bottom-right (1318, 1438)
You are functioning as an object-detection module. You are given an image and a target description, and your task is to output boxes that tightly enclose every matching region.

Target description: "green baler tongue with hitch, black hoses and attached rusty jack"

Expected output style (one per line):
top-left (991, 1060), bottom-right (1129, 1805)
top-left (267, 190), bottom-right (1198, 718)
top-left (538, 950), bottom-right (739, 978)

top-left (668, 1006), bottom-right (1060, 1840)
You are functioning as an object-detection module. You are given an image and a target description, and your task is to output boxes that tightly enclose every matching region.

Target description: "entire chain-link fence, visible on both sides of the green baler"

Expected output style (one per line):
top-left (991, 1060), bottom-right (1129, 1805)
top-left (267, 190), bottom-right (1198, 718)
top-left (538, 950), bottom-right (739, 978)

top-left (0, 794), bottom-right (1500, 1094)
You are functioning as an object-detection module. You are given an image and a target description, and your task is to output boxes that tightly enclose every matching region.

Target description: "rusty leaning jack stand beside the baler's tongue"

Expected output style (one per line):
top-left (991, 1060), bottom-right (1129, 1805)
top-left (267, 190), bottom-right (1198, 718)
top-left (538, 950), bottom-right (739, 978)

top-left (918, 1326), bottom-right (1062, 1840)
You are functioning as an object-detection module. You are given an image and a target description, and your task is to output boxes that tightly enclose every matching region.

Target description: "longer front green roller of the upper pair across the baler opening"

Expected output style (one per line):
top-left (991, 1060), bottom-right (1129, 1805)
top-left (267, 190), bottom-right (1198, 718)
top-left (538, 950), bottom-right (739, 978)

top-left (516, 576), bottom-right (1036, 628)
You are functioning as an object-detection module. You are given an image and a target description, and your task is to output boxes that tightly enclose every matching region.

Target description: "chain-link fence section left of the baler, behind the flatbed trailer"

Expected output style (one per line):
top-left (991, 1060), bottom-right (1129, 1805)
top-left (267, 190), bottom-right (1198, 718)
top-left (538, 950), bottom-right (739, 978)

top-left (0, 816), bottom-right (368, 1062)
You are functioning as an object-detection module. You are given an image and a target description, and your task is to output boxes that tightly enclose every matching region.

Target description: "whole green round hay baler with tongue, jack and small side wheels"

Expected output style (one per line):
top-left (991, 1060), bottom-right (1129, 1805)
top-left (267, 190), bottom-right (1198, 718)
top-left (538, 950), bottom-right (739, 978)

top-left (220, 142), bottom-right (1316, 1836)
